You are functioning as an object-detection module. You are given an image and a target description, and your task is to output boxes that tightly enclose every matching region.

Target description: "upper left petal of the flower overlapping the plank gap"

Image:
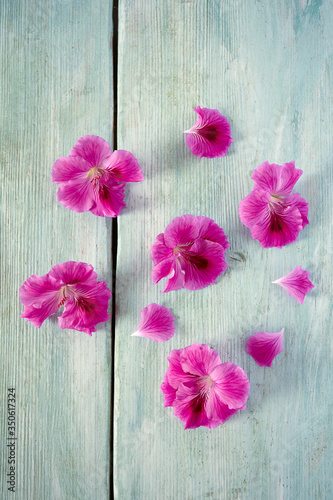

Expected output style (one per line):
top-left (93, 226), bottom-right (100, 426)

top-left (51, 156), bottom-right (91, 184)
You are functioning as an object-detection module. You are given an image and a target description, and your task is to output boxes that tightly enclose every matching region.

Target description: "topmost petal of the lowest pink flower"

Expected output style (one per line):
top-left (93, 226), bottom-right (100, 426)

top-left (180, 342), bottom-right (221, 377)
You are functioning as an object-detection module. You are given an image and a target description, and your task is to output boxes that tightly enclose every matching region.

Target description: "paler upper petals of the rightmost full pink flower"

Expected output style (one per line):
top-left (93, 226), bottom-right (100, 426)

top-left (251, 161), bottom-right (303, 197)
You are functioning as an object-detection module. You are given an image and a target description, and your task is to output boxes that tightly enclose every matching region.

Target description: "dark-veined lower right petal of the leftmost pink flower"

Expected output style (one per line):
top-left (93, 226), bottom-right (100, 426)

top-left (58, 281), bottom-right (111, 335)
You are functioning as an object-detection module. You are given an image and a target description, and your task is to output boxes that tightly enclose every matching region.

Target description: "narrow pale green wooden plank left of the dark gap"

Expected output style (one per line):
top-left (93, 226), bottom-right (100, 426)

top-left (0, 0), bottom-right (113, 500)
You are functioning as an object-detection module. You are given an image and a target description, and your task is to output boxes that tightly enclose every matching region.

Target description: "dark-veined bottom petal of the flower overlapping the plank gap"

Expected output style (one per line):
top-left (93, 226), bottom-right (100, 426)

top-left (90, 180), bottom-right (126, 217)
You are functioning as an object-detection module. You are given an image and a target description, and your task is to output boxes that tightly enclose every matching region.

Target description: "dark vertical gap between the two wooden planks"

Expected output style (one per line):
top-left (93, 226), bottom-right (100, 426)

top-left (109, 0), bottom-right (118, 500)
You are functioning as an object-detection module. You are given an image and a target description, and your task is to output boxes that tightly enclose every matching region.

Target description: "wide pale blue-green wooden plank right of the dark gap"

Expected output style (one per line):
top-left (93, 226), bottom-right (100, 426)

top-left (115, 0), bottom-right (333, 500)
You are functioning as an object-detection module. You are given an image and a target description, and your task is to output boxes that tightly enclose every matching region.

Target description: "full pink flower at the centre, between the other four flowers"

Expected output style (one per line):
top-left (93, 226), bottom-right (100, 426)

top-left (151, 215), bottom-right (230, 292)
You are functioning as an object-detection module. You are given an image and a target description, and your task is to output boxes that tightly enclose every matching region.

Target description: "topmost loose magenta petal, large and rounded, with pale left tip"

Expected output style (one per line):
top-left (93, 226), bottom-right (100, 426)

top-left (184, 106), bottom-right (233, 158)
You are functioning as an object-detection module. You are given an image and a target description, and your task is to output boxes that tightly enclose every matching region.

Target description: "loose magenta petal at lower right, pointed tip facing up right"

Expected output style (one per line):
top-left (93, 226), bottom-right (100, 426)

top-left (246, 328), bottom-right (284, 366)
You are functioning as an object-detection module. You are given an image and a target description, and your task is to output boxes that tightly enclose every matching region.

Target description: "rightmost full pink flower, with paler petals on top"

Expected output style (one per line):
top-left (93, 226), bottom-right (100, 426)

top-left (239, 161), bottom-right (309, 248)
